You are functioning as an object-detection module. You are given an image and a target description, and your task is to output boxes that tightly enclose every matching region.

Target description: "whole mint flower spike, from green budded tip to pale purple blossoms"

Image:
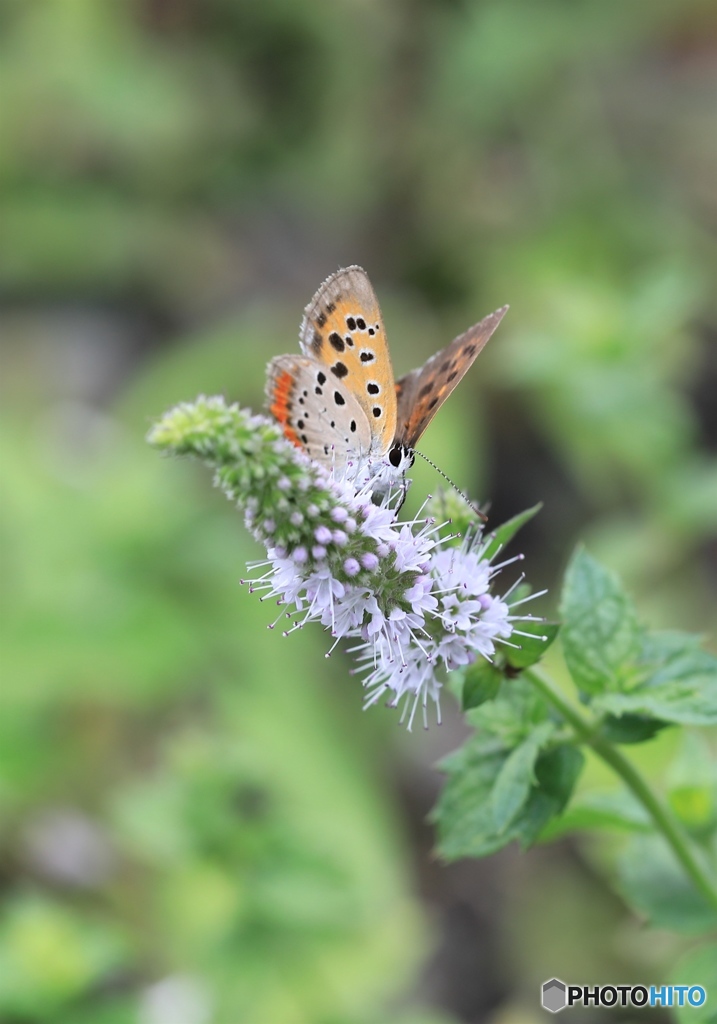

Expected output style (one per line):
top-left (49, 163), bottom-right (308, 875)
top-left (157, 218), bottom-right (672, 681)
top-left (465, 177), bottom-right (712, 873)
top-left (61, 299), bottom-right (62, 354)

top-left (147, 397), bottom-right (530, 728)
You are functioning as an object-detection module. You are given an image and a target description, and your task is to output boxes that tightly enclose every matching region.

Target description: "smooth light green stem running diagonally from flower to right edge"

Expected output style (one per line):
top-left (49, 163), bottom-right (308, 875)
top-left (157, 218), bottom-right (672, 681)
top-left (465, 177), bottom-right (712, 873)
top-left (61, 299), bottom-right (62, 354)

top-left (523, 666), bottom-right (717, 908)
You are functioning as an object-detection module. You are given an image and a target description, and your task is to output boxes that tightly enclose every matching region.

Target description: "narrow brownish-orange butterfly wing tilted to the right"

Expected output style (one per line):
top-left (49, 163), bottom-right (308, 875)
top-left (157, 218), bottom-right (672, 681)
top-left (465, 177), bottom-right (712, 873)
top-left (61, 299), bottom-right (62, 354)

top-left (395, 306), bottom-right (508, 449)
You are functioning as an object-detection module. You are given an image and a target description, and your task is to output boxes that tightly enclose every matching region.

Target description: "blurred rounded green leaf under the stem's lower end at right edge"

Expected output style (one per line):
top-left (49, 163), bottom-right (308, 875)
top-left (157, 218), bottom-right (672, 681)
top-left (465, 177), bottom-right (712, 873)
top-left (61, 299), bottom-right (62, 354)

top-left (618, 836), bottom-right (717, 935)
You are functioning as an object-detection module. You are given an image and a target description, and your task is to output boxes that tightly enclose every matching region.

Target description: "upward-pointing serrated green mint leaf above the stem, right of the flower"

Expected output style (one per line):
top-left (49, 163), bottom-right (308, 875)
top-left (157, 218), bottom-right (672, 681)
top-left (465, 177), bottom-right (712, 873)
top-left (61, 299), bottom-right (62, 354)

top-left (560, 548), bottom-right (642, 695)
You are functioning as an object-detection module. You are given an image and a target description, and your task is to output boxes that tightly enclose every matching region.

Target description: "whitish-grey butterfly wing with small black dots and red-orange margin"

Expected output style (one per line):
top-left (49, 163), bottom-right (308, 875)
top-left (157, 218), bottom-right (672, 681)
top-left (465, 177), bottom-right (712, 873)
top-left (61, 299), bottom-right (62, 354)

top-left (266, 355), bottom-right (371, 469)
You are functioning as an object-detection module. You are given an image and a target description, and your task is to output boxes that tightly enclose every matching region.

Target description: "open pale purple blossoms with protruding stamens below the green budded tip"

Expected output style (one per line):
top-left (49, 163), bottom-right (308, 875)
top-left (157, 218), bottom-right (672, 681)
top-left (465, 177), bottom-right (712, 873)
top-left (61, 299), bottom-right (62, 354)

top-left (240, 456), bottom-right (520, 728)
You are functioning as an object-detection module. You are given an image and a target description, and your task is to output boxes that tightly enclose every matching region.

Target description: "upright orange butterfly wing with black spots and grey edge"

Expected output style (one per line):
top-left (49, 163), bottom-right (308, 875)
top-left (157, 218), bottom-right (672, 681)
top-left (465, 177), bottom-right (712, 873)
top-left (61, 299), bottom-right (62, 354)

top-left (299, 266), bottom-right (396, 456)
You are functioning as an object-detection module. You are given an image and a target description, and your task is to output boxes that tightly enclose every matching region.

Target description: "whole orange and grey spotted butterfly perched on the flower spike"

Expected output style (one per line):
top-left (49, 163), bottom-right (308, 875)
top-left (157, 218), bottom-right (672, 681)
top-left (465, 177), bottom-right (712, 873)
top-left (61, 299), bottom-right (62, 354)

top-left (266, 266), bottom-right (508, 485)
